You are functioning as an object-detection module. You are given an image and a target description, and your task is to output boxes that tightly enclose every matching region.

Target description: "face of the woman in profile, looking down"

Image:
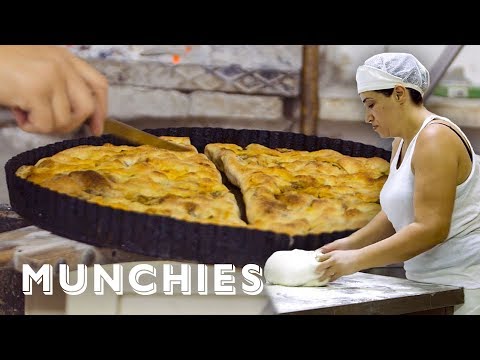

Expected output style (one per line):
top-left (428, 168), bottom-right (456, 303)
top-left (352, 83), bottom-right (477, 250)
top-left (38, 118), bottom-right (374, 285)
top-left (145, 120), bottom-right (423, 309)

top-left (360, 91), bottom-right (398, 138)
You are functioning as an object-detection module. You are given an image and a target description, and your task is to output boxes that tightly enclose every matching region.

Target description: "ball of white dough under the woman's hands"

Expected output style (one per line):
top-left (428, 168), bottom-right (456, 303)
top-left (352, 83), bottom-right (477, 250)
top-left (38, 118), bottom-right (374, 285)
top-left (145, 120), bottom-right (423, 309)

top-left (263, 249), bottom-right (329, 286)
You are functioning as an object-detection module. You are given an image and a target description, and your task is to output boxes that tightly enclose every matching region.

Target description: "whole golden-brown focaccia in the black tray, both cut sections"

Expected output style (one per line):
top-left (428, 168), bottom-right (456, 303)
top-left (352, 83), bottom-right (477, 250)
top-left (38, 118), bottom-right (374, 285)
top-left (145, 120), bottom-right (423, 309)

top-left (17, 136), bottom-right (389, 235)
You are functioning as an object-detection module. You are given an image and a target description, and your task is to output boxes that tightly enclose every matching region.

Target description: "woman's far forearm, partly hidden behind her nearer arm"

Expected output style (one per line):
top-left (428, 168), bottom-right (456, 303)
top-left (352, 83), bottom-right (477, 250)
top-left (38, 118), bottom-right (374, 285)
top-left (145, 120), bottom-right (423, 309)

top-left (348, 211), bottom-right (395, 249)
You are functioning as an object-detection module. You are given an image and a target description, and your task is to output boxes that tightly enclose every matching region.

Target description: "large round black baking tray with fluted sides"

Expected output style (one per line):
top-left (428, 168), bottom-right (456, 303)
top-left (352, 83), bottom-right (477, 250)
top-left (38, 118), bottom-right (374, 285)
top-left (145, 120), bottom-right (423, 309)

top-left (5, 127), bottom-right (391, 266)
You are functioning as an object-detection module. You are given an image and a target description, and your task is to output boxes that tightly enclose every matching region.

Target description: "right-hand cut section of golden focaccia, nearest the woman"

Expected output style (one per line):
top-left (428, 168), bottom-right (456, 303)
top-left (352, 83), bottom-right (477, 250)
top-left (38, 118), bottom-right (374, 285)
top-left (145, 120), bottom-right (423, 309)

top-left (205, 143), bottom-right (389, 235)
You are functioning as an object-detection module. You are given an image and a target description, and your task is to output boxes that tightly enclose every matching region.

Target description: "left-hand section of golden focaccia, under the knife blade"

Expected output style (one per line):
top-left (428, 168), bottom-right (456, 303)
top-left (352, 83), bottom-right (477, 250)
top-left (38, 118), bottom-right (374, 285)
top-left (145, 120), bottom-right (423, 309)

top-left (16, 136), bottom-right (246, 226)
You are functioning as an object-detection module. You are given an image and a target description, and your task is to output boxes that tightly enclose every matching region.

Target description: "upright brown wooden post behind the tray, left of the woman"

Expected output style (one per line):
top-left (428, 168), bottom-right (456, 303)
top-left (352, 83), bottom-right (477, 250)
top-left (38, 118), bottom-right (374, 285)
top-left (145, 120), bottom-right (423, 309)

top-left (300, 45), bottom-right (319, 135)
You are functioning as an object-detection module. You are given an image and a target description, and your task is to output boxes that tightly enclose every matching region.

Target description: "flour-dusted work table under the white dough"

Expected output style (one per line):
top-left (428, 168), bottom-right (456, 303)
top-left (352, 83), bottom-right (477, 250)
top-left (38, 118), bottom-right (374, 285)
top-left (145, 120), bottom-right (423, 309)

top-left (267, 272), bottom-right (463, 315)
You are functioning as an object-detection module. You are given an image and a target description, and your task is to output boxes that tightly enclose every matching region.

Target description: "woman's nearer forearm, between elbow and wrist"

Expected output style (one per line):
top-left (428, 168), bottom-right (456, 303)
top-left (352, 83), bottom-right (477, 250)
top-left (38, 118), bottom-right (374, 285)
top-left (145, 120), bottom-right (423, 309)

top-left (359, 223), bottom-right (447, 269)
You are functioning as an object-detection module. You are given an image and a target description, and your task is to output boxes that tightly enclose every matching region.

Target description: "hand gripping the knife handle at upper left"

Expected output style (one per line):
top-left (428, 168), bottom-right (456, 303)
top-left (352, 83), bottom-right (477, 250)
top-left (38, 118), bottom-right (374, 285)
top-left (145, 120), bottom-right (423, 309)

top-left (0, 45), bottom-right (108, 135)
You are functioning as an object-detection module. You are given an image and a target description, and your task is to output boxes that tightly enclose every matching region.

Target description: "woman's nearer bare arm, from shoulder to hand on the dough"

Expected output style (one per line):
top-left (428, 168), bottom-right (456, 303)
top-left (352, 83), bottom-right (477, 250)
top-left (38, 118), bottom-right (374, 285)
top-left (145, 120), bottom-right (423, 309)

top-left (317, 126), bottom-right (464, 280)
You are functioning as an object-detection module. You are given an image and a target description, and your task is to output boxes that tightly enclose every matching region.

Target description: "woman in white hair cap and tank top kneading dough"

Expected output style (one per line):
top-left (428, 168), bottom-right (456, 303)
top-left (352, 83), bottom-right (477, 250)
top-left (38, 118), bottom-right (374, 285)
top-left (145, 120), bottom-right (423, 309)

top-left (317, 53), bottom-right (480, 314)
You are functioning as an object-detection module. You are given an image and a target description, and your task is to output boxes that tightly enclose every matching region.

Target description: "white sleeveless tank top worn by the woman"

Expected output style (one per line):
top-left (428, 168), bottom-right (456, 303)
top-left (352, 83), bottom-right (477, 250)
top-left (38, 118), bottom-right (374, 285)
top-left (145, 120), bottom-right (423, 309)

top-left (380, 115), bottom-right (480, 289)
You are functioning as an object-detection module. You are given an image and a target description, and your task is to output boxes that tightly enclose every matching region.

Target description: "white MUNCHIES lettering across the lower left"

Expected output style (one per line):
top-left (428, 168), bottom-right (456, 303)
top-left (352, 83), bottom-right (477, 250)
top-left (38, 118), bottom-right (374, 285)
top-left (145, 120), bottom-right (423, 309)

top-left (22, 263), bottom-right (264, 295)
